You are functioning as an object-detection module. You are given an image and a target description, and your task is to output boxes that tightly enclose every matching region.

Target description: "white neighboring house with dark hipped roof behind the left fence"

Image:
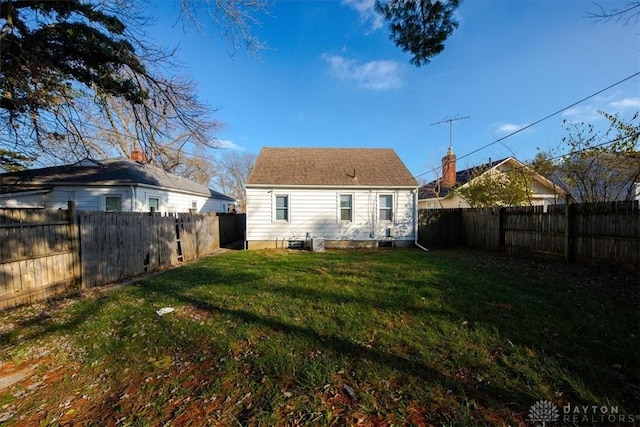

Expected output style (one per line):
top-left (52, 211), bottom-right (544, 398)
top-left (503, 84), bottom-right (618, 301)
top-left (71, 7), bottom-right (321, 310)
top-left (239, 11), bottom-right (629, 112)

top-left (0, 153), bottom-right (236, 213)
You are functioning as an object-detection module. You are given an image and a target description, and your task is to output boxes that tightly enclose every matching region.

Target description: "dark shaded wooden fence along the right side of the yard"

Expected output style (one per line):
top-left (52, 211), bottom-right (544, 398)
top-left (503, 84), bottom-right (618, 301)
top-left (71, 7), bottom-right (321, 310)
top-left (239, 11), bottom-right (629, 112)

top-left (418, 201), bottom-right (640, 270)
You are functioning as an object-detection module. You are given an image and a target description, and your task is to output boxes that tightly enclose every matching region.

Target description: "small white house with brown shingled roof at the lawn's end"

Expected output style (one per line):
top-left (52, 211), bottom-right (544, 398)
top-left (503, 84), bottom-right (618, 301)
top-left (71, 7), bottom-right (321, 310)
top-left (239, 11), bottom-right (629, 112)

top-left (246, 147), bottom-right (418, 249)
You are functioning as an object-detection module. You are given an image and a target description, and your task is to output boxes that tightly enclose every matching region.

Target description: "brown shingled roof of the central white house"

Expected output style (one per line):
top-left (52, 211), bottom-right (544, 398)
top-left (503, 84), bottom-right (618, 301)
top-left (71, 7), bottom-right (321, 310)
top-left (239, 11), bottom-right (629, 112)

top-left (247, 147), bottom-right (418, 188)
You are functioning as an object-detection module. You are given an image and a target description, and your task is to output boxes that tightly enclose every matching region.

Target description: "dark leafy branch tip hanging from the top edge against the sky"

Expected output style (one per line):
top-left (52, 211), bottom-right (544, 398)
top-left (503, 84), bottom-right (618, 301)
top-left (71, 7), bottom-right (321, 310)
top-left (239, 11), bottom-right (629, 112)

top-left (375, 0), bottom-right (462, 67)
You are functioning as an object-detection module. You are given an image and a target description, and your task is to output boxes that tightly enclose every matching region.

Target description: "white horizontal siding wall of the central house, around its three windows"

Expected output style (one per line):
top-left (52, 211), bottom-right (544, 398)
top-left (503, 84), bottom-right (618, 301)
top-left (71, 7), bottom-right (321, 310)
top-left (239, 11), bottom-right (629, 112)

top-left (247, 186), bottom-right (416, 249)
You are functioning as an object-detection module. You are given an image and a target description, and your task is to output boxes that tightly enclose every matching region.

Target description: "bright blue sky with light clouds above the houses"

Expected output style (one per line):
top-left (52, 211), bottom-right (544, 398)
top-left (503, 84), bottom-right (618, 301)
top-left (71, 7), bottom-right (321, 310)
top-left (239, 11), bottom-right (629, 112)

top-left (147, 0), bottom-right (640, 180)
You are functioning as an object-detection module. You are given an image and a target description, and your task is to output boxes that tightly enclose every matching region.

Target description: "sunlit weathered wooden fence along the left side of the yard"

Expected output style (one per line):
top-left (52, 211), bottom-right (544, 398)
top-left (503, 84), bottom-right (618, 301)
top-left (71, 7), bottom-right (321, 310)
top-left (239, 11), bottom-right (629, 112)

top-left (0, 205), bottom-right (244, 309)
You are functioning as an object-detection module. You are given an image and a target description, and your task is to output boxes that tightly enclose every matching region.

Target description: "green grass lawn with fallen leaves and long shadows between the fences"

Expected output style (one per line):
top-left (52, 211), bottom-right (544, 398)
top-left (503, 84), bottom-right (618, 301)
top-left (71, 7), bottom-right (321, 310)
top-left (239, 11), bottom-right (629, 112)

top-left (0, 249), bottom-right (640, 426)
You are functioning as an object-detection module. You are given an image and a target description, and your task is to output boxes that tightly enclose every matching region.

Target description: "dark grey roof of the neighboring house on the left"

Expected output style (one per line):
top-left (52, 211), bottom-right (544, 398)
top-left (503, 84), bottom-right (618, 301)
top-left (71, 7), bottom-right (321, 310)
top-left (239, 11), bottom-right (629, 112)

top-left (0, 158), bottom-right (212, 197)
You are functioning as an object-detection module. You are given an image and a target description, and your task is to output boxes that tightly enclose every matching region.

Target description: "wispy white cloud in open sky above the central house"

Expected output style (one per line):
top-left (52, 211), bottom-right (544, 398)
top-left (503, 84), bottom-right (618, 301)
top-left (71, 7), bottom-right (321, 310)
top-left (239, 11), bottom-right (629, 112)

top-left (322, 54), bottom-right (402, 90)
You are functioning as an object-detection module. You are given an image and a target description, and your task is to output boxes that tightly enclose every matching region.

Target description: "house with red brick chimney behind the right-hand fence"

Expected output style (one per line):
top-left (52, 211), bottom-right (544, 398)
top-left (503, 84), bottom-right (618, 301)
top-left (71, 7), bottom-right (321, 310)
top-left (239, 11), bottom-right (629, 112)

top-left (418, 148), bottom-right (567, 209)
